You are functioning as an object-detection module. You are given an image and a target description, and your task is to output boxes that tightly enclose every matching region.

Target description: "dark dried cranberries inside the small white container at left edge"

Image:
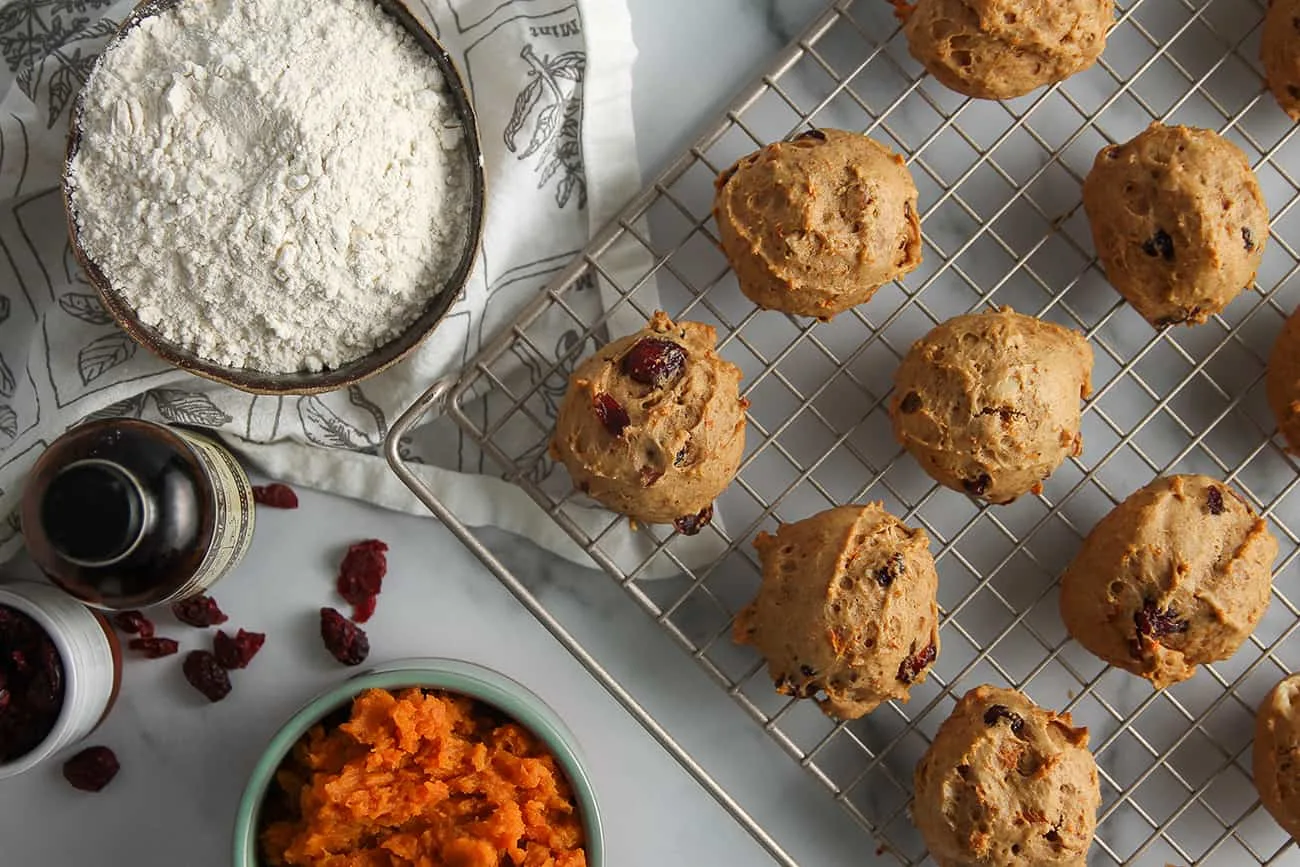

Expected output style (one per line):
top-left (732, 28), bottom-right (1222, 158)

top-left (0, 606), bottom-right (64, 763)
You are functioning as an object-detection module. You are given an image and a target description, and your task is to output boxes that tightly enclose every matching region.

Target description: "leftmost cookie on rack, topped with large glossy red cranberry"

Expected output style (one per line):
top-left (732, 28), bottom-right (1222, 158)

top-left (551, 312), bottom-right (749, 534)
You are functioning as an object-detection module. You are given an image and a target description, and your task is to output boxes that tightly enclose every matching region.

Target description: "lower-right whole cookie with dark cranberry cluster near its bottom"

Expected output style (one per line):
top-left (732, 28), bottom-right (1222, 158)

top-left (1061, 476), bottom-right (1278, 689)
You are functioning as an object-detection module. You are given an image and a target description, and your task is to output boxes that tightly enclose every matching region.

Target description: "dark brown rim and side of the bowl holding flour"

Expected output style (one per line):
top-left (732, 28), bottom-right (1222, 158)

top-left (62, 0), bottom-right (485, 394)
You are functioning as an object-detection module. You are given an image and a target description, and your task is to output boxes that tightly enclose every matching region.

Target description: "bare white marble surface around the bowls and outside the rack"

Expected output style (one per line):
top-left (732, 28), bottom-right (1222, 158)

top-left (0, 0), bottom-right (894, 867)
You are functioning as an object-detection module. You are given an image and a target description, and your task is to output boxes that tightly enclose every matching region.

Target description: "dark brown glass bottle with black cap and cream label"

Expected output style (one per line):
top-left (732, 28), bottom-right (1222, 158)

top-left (21, 419), bottom-right (254, 611)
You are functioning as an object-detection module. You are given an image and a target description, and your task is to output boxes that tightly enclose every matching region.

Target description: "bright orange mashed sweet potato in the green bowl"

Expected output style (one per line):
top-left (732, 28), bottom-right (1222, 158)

top-left (261, 689), bottom-right (586, 867)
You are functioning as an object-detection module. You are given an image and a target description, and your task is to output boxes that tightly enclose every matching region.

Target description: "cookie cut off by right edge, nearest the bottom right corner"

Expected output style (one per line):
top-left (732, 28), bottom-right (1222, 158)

top-left (1251, 675), bottom-right (1300, 840)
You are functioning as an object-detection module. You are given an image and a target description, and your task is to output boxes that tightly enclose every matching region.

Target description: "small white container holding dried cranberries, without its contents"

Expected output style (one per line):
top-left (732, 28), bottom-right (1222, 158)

top-left (0, 581), bottom-right (122, 780)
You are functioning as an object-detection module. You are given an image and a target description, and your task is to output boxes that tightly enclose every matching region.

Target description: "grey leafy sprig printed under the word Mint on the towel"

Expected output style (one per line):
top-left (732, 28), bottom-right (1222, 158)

top-left (502, 44), bottom-right (586, 211)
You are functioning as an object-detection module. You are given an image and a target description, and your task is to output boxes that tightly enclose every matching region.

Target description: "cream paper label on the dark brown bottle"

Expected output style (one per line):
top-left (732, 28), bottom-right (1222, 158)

top-left (168, 428), bottom-right (255, 602)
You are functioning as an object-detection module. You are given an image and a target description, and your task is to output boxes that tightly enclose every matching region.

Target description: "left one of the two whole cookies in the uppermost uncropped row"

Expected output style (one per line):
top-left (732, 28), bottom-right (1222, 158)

top-left (714, 130), bottom-right (920, 320)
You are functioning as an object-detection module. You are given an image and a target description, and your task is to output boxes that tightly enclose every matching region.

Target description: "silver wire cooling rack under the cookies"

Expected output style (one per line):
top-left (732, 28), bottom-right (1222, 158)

top-left (389, 0), bottom-right (1300, 864)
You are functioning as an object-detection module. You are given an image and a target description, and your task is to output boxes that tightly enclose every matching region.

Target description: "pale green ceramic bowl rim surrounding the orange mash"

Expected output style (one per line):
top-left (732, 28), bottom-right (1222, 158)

top-left (234, 659), bottom-right (605, 867)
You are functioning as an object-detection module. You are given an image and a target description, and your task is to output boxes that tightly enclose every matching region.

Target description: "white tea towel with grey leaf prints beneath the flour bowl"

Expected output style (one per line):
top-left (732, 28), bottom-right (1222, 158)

top-left (0, 0), bottom-right (676, 562)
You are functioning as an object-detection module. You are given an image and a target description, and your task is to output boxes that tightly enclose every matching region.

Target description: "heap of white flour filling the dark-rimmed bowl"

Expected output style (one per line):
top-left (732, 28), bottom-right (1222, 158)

top-left (72, 0), bottom-right (468, 372)
